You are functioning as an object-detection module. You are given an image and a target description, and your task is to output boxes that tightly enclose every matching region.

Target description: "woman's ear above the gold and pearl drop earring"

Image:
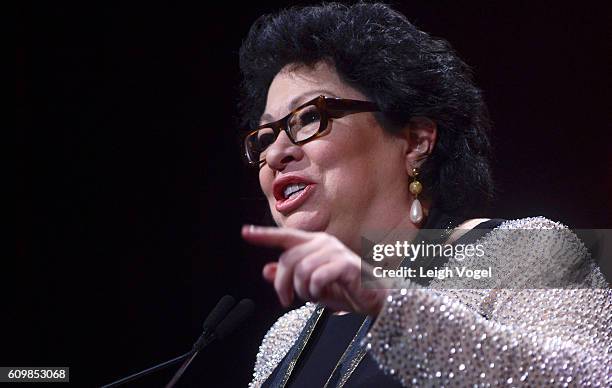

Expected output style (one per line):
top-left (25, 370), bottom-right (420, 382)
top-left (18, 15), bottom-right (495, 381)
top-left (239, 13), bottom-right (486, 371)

top-left (405, 116), bottom-right (438, 175)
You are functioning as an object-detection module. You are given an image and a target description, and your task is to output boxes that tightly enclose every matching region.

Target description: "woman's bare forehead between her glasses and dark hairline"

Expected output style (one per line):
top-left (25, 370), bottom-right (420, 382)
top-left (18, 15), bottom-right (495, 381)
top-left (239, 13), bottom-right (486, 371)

top-left (261, 62), bottom-right (364, 122)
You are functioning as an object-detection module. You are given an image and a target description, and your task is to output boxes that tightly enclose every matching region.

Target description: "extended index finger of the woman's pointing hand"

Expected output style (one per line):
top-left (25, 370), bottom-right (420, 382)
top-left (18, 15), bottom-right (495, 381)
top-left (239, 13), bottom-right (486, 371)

top-left (242, 225), bottom-right (315, 249)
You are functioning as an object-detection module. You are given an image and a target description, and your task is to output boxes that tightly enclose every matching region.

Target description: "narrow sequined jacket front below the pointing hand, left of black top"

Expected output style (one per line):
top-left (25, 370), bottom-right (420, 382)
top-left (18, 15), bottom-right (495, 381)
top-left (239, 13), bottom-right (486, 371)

top-left (249, 303), bottom-right (316, 387)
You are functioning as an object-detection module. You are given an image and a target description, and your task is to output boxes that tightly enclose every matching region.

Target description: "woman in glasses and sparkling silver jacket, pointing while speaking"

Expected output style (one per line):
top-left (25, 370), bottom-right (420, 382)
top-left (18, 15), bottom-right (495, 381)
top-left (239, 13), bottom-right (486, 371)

top-left (240, 4), bottom-right (612, 386)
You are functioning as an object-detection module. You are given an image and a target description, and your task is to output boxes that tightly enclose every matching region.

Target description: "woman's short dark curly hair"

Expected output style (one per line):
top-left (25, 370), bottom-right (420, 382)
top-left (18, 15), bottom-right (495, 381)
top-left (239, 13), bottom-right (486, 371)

top-left (240, 3), bottom-right (493, 216)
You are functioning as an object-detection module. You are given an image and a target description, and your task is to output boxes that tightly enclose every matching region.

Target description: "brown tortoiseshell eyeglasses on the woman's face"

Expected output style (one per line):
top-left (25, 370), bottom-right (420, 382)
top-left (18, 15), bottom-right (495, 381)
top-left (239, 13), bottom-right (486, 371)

top-left (244, 95), bottom-right (379, 166)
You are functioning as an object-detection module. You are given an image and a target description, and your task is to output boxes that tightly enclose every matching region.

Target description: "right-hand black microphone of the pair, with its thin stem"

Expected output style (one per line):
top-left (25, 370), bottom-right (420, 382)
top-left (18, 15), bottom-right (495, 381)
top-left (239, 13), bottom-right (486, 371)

top-left (166, 298), bottom-right (255, 388)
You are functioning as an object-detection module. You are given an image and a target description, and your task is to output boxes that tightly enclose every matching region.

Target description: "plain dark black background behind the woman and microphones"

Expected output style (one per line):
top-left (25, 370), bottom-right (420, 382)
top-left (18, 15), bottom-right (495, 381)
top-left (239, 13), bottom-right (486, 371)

top-left (16, 1), bottom-right (612, 386)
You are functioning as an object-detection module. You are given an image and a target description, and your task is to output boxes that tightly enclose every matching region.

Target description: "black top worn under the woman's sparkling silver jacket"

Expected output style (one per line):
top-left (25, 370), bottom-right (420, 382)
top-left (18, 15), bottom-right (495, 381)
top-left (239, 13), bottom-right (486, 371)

top-left (263, 213), bottom-right (504, 388)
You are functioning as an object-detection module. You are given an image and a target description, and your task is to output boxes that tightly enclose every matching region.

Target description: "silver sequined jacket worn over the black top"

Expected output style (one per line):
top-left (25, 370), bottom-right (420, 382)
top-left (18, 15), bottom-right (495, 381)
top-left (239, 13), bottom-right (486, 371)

top-left (250, 217), bottom-right (612, 387)
